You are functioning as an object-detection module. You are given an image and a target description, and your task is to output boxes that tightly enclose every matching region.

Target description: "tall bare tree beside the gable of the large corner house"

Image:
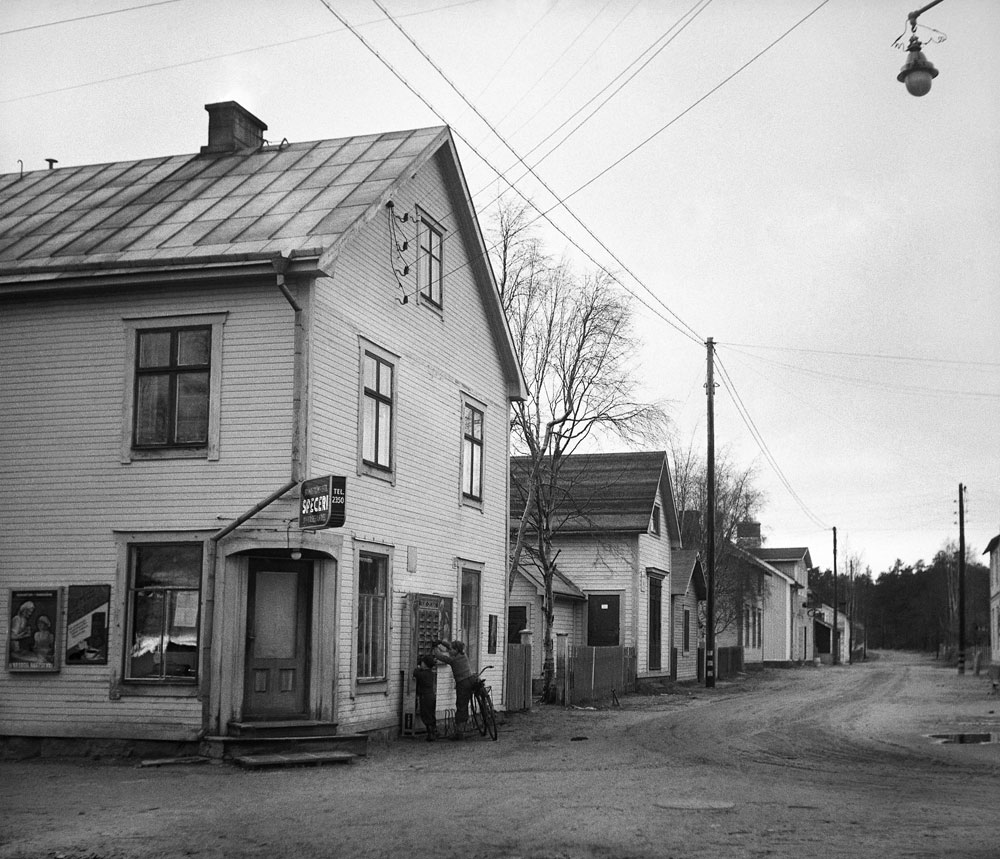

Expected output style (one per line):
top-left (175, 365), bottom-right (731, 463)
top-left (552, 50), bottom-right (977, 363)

top-left (493, 198), bottom-right (666, 695)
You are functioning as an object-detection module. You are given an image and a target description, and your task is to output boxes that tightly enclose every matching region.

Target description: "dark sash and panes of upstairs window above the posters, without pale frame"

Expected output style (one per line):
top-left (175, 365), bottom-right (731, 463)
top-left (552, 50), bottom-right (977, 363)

top-left (133, 326), bottom-right (212, 448)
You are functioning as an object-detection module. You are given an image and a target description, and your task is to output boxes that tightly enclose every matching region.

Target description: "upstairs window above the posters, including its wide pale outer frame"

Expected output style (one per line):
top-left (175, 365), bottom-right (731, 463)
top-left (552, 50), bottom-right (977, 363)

top-left (122, 314), bottom-right (225, 463)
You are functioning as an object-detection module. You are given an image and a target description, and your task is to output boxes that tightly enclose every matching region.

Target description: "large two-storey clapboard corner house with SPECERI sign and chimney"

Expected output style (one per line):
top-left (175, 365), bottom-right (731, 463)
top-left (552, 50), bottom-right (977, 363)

top-left (0, 102), bottom-right (525, 756)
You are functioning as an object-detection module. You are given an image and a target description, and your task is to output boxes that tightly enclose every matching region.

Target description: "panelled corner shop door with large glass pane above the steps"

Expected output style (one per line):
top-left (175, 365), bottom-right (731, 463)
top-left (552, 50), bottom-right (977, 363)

top-left (243, 558), bottom-right (312, 719)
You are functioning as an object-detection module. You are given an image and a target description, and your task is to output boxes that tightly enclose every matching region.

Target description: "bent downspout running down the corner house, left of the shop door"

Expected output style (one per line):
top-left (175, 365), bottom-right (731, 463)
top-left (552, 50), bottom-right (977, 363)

top-left (201, 254), bottom-right (305, 733)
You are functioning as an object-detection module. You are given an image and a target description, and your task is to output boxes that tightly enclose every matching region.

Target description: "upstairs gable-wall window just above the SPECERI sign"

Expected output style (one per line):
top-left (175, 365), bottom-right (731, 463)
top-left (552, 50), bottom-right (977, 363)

top-left (359, 344), bottom-right (396, 477)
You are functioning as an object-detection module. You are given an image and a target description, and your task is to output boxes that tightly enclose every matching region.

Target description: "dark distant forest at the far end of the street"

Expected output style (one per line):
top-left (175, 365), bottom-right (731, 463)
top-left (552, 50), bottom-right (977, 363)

top-left (809, 545), bottom-right (990, 652)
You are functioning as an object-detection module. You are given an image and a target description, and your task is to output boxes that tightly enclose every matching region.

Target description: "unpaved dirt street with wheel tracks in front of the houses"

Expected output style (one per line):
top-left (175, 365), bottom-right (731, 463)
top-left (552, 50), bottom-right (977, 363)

top-left (0, 654), bottom-right (1000, 859)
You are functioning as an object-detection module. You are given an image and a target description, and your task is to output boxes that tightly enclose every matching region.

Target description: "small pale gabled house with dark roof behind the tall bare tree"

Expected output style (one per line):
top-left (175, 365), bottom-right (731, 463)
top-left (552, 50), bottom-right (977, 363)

top-left (509, 451), bottom-right (691, 677)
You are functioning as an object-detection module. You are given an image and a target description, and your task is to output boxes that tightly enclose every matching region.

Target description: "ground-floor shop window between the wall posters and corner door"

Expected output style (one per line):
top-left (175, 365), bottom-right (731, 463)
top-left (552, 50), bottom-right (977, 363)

top-left (125, 542), bottom-right (202, 683)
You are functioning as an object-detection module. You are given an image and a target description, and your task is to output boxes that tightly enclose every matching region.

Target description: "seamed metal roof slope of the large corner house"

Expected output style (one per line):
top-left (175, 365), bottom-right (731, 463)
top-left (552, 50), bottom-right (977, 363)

top-left (0, 127), bottom-right (449, 282)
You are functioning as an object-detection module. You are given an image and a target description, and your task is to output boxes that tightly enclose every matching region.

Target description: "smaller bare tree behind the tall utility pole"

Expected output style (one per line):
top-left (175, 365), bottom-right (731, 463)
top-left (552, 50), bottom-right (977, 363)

top-left (670, 444), bottom-right (765, 634)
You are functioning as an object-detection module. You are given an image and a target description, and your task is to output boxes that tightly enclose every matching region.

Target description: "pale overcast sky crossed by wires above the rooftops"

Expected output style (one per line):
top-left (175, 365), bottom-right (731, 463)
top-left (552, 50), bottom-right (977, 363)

top-left (0, 0), bottom-right (1000, 573)
